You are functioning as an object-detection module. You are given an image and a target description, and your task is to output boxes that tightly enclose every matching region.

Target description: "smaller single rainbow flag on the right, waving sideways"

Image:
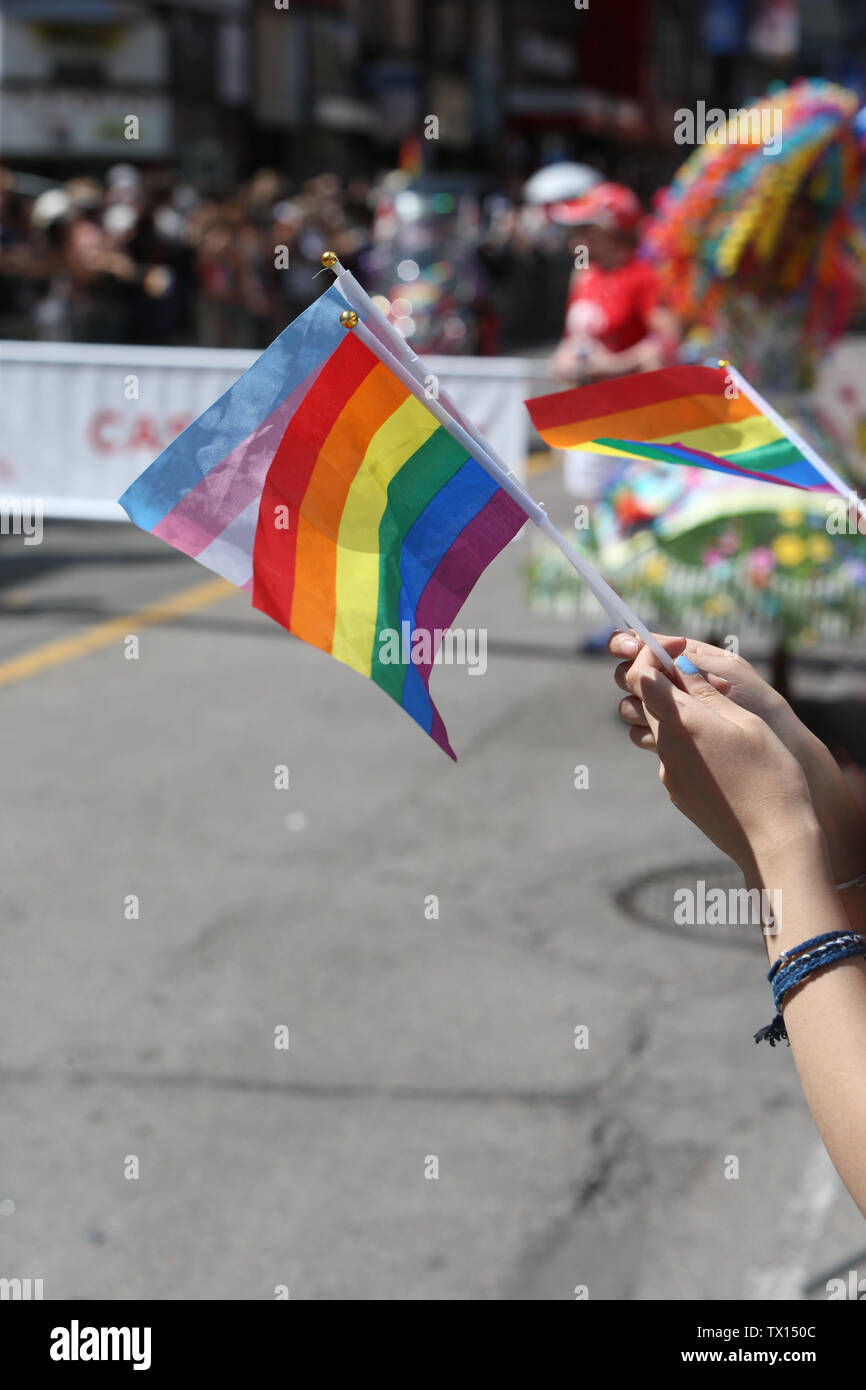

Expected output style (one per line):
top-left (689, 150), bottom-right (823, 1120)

top-left (527, 367), bottom-right (835, 492)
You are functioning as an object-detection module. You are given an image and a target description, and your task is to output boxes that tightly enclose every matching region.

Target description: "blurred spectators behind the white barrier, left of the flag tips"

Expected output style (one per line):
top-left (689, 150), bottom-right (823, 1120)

top-left (0, 164), bottom-right (370, 348)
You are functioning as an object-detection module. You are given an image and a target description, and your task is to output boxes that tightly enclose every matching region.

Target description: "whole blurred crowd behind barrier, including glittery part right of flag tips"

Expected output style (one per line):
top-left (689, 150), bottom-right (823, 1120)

top-left (0, 164), bottom-right (567, 353)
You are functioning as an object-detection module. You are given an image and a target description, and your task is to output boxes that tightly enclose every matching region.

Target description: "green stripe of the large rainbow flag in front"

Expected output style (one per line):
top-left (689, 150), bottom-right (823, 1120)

top-left (370, 425), bottom-right (466, 702)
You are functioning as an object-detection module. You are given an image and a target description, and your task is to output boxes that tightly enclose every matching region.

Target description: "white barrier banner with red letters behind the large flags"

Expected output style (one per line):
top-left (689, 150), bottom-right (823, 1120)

top-left (0, 342), bottom-right (538, 521)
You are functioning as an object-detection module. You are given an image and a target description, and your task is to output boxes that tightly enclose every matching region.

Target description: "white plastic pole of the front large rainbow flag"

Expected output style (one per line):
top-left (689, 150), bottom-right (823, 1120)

top-left (341, 300), bottom-right (676, 678)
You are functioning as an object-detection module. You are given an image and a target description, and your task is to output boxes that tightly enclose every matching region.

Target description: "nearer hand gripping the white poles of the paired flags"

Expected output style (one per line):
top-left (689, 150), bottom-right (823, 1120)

top-left (626, 636), bottom-right (820, 877)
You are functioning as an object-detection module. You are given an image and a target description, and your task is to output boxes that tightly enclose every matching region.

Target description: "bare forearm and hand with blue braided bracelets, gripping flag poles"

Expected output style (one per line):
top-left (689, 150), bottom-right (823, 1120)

top-left (620, 639), bottom-right (866, 1215)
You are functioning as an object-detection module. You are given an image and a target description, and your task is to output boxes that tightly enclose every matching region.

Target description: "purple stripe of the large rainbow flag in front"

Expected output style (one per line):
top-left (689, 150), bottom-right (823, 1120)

top-left (414, 489), bottom-right (527, 762)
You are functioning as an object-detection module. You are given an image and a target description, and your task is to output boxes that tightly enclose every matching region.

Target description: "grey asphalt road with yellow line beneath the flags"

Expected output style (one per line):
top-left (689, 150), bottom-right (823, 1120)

top-left (0, 472), bottom-right (866, 1300)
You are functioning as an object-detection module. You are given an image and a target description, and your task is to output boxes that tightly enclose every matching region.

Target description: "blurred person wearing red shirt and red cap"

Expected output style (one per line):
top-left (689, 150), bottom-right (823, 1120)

top-left (549, 183), bottom-right (680, 385)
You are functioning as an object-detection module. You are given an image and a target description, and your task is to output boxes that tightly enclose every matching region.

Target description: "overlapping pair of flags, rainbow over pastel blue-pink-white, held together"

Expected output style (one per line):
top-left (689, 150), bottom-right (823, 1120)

top-left (120, 286), bottom-right (527, 759)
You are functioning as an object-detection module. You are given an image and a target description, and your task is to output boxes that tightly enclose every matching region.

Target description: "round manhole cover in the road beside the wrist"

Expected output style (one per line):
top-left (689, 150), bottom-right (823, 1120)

top-left (613, 859), bottom-right (773, 951)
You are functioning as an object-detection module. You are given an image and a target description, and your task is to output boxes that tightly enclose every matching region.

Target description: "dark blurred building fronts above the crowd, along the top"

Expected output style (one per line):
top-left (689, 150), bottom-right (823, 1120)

top-left (0, 0), bottom-right (866, 193)
